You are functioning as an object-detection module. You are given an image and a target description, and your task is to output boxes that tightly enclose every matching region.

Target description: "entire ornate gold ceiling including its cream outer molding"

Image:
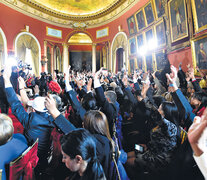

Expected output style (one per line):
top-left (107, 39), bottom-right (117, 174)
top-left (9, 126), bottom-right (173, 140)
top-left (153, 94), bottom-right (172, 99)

top-left (1, 0), bottom-right (139, 28)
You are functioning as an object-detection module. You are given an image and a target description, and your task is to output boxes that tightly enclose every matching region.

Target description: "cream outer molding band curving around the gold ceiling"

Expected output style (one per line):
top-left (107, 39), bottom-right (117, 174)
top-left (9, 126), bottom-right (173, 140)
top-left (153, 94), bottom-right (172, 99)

top-left (1, 0), bottom-right (140, 28)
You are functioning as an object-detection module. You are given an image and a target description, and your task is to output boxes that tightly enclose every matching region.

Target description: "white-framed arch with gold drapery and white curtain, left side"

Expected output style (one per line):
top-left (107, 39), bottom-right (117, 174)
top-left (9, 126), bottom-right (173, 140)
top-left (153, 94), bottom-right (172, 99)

top-left (15, 32), bottom-right (41, 75)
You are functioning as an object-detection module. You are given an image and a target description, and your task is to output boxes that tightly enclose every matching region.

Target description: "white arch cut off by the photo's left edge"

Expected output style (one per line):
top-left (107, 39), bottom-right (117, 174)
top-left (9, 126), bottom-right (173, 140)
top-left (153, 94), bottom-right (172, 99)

top-left (0, 28), bottom-right (7, 69)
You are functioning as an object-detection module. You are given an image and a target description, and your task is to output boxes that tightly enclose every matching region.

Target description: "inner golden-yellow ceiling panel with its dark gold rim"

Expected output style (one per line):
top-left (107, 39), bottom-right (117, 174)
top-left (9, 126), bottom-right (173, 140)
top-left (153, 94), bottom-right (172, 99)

top-left (17, 0), bottom-right (126, 20)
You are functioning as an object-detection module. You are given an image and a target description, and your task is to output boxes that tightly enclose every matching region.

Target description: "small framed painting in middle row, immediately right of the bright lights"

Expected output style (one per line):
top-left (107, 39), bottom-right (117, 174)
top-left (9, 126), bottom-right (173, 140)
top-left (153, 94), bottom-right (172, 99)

top-left (155, 20), bottom-right (166, 46)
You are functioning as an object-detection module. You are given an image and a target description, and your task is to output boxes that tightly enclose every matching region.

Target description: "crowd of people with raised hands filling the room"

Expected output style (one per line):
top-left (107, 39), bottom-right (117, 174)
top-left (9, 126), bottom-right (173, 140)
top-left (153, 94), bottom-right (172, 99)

top-left (0, 60), bottom-right (207, 180)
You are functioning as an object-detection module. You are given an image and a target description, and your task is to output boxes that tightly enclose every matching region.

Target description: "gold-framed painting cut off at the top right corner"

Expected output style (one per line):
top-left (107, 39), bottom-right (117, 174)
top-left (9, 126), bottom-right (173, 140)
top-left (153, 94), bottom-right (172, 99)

top-left (191, 0), bottom-right (207, 32)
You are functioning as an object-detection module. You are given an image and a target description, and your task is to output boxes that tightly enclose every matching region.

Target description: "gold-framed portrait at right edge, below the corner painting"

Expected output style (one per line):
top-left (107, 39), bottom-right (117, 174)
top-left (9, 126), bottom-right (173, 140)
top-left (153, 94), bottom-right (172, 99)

top-left (191, 34), bottom-right (207, 72)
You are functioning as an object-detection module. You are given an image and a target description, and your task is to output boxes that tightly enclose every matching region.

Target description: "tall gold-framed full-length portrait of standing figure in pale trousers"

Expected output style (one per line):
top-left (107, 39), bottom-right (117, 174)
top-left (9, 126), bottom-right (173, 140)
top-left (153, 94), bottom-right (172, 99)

top-left (168, 0), bottom-right (188, 42)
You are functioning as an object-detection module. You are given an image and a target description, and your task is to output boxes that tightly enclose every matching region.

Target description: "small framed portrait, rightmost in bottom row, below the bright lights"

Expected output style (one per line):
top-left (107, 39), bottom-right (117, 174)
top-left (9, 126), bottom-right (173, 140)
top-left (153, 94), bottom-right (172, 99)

top-left (155, 50), bottom-right (169, 71)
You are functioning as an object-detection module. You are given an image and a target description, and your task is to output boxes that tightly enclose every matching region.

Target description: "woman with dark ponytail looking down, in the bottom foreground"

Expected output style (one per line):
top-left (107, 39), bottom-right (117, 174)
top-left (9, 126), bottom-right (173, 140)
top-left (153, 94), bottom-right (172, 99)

top-left (61, 129), bottom-right (106, 180)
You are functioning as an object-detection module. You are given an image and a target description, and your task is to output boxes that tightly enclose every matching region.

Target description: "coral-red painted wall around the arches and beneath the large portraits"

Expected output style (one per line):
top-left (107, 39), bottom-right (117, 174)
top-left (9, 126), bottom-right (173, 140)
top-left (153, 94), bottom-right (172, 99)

top-left (0, 0), bottom-right (196, 69)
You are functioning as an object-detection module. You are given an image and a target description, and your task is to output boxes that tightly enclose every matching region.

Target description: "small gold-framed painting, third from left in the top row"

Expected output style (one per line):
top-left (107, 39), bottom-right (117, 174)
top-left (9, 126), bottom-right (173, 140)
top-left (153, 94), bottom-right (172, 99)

top-left (143, 1), bottom-right (155, 26)
